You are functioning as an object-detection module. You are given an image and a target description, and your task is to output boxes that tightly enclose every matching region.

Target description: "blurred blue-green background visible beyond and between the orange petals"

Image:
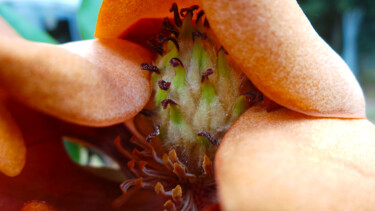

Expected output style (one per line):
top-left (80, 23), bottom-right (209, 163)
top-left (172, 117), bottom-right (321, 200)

top-left (0, 0), bottom-right (375, 166)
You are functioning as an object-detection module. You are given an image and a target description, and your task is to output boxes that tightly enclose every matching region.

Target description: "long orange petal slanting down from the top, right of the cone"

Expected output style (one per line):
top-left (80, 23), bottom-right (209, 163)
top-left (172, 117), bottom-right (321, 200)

top-left (202, 0), bottom-right (365, 118)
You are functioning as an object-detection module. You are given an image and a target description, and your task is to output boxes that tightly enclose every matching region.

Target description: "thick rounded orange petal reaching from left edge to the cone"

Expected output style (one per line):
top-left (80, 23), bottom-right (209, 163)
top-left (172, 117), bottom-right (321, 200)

top-left (0, 39), bottom-right (151, 126)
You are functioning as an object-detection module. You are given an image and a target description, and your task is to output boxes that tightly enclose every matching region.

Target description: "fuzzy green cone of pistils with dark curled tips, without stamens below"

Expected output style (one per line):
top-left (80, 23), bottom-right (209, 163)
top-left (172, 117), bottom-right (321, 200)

top-left (144, 4), bottom-right (256, 159)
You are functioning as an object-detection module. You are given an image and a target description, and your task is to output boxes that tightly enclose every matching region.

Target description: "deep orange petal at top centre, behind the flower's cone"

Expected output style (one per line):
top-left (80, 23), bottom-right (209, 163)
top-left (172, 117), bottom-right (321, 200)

top-left (95, 0), bottom-right (199, 38)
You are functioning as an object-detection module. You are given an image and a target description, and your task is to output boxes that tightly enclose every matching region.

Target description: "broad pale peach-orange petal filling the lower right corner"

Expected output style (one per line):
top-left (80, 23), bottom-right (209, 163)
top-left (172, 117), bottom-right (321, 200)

top-left (215, 107), bottom-right (375, 210)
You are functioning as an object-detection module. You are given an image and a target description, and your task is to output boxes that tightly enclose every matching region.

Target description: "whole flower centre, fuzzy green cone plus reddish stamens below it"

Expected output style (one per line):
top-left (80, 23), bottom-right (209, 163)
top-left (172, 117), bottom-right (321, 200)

top-left (116, 4), bottom-right (262, 210)
